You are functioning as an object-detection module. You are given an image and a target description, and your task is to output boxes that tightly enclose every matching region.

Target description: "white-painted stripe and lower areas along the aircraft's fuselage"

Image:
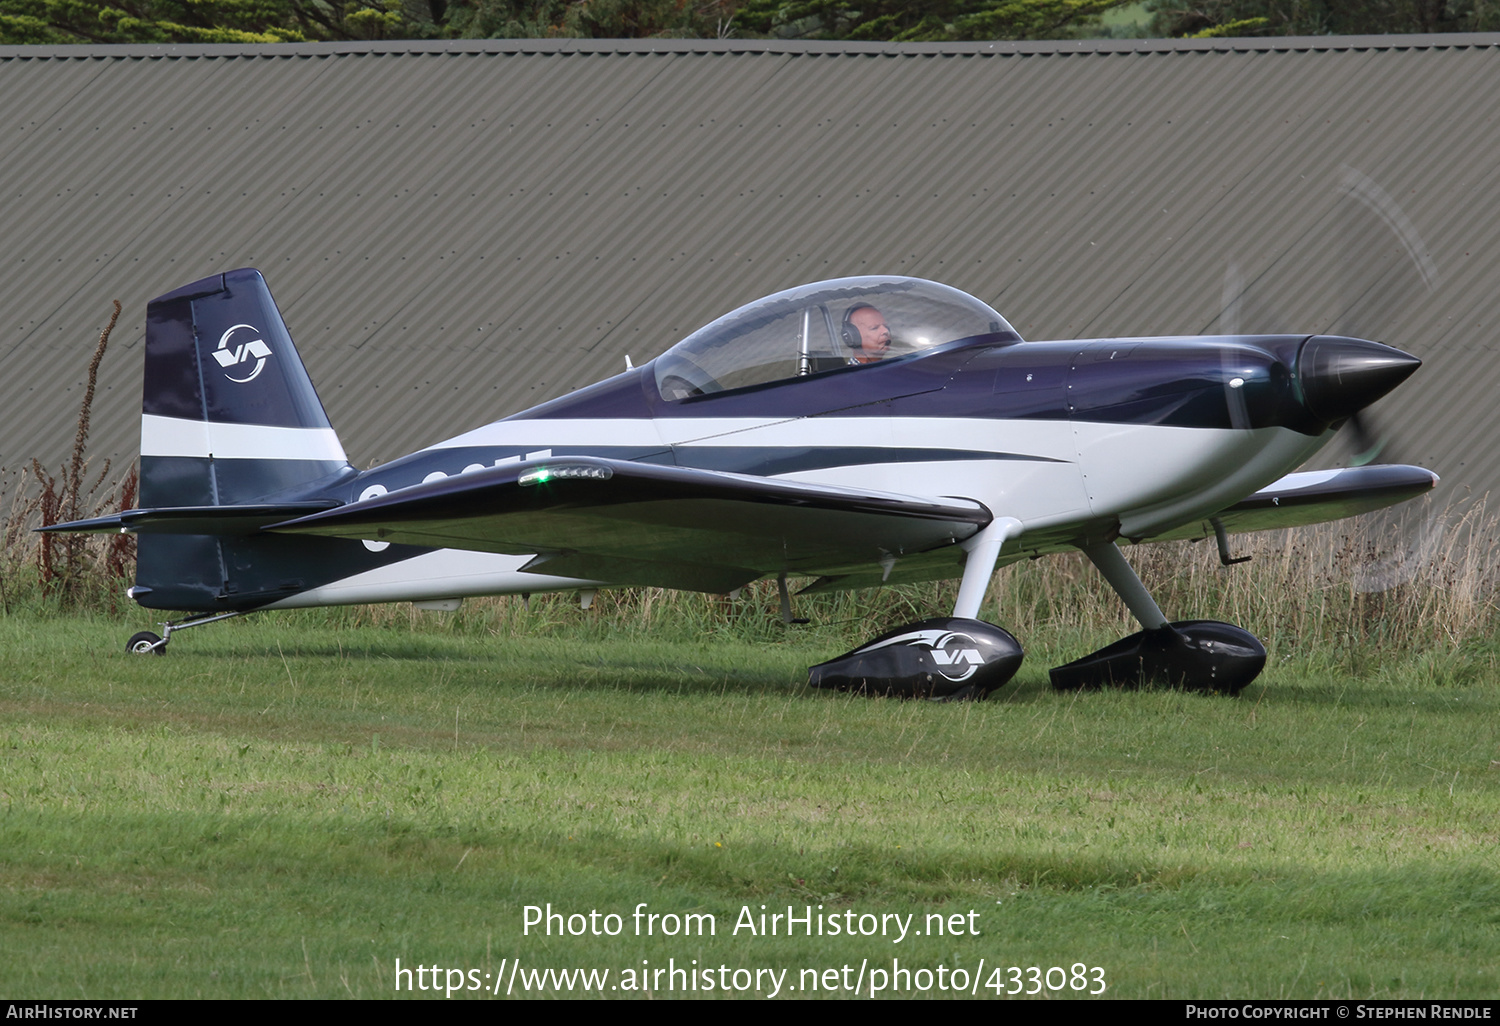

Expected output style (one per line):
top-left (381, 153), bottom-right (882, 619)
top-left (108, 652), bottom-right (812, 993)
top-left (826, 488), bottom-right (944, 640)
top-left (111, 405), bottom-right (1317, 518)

top-left (276, 417), bottom-right (1322, 608)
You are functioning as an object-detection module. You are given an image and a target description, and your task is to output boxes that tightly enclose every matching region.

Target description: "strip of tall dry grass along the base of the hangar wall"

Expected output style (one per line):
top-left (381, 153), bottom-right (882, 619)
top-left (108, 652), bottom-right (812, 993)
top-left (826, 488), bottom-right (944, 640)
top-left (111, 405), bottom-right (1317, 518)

top-left (0, 492), bottom-right (1500, 669)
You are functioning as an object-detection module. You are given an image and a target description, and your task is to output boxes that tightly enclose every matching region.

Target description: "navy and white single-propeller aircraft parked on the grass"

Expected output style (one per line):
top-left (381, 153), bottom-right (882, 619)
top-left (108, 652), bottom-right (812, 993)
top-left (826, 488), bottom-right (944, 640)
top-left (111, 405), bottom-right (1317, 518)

top-left (45, 269), bottom-right (1437, 699)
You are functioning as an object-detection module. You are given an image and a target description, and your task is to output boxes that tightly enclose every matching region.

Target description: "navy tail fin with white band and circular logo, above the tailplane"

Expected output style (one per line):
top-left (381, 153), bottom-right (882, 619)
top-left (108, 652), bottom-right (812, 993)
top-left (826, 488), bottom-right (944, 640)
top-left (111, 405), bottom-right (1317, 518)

top-left (141, 269), bottom-right (353, 509)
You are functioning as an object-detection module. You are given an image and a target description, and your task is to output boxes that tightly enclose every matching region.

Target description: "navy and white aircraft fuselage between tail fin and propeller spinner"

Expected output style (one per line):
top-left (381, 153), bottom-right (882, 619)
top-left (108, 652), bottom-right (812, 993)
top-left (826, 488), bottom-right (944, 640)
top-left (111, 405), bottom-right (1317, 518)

top-left (258, 335), bottom-right (1331, 606)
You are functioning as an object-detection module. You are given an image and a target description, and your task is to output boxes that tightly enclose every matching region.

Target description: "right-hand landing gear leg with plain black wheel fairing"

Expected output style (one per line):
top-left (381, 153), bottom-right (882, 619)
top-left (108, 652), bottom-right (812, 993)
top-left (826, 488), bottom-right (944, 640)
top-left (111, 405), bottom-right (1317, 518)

top-left (1052, 542), bottom-right (1266, 695)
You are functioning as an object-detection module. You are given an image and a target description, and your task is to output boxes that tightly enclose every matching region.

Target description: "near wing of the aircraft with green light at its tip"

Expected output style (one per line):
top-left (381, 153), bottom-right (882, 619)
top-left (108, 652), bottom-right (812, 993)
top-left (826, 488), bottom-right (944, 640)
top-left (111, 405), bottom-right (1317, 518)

top-left (266, 456), bottom-right (992, 593)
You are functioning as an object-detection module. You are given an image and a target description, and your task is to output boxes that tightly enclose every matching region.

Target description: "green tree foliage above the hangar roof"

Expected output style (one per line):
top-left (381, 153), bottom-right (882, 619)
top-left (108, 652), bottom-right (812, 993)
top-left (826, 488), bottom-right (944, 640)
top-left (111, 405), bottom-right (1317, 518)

top-left (0, 0), bottom-right (1500, 44)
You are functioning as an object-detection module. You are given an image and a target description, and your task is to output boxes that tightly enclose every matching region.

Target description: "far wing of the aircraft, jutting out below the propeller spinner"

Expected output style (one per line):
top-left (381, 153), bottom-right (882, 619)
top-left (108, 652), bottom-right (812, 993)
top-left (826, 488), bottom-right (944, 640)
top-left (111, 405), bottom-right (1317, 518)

top-left (1149, 464), bottom-right (1437, 542)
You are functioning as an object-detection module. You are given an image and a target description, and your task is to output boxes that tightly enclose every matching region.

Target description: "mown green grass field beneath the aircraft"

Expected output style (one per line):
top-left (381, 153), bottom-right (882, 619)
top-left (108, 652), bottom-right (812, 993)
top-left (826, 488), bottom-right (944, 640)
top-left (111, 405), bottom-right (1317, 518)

top-left (0, 585), bottom-right (1500, 999)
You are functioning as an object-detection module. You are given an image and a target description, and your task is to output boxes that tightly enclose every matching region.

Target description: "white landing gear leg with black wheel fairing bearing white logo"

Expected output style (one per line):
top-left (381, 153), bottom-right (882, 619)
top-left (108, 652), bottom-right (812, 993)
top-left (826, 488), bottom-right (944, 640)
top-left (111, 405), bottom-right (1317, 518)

top-left (809, 518), bottom-right (1023, 702)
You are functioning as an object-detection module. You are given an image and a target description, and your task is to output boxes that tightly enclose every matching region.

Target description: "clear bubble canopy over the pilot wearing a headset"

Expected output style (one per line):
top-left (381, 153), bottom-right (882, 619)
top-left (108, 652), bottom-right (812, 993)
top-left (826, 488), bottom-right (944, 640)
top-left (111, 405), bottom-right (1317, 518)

top-left (656, 278), bottom-right (1020, 401)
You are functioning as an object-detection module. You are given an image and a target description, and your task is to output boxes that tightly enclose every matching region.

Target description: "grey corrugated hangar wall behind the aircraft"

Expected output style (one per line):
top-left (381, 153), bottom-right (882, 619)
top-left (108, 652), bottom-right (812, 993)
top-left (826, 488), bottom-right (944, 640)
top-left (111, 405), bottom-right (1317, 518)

top-left (0, 35), bottom-right (1500, 497)
